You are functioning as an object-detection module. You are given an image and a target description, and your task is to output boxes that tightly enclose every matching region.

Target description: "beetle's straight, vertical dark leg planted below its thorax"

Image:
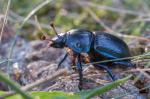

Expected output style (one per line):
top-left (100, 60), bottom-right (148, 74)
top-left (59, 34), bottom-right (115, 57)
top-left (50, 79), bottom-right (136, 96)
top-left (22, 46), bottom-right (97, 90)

top-left (77, 54), bottom-right (83, 90)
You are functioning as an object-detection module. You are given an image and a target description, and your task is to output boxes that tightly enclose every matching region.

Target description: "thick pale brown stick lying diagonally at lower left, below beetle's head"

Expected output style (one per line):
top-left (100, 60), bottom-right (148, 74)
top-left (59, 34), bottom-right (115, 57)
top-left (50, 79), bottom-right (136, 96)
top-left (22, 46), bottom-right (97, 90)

top-left (2, 69), bottom-right (67, 99)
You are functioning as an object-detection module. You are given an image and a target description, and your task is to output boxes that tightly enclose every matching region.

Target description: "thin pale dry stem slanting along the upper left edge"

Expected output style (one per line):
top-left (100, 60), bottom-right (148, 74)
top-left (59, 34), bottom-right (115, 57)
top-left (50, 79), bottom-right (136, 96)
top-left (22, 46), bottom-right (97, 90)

top-left (0, 0), bottom-right (11, 43)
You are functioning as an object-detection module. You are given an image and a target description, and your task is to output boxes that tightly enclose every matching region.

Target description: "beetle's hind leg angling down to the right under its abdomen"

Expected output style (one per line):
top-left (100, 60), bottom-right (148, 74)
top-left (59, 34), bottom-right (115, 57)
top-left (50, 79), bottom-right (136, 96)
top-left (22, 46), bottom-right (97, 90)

top-left (95, 64), bottom-right (117, 81)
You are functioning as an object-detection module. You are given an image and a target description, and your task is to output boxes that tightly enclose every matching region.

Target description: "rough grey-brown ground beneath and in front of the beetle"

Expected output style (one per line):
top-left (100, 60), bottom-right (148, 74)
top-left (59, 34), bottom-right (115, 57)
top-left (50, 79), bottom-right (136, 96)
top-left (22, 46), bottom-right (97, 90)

top-left (0, 33), bottom-right (150, 99)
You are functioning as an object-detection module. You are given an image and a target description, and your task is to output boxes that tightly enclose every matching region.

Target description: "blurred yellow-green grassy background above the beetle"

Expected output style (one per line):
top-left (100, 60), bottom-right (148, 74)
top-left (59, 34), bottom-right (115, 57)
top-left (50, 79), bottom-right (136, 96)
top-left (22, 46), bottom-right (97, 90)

top-left (0, 0), bottom-right (150, 39)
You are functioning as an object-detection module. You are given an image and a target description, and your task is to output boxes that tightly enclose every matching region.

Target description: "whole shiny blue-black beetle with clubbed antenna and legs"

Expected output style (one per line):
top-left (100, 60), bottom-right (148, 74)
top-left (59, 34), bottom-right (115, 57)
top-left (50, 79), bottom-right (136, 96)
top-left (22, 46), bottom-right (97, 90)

top-left (43, 24), bottom-right (134, 90)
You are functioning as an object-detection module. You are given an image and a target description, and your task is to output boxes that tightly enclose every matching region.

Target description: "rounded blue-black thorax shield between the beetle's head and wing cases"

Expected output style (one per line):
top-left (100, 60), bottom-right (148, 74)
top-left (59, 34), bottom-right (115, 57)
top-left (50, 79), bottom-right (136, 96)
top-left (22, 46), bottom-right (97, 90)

top-left (66, 29), bottom-right (93, 53)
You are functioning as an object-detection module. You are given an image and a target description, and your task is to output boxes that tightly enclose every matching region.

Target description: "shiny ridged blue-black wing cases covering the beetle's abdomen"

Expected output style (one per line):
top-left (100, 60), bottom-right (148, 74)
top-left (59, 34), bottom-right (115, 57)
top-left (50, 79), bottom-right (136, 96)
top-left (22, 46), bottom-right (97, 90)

top-left (94, 32), bottom-right (130, 59)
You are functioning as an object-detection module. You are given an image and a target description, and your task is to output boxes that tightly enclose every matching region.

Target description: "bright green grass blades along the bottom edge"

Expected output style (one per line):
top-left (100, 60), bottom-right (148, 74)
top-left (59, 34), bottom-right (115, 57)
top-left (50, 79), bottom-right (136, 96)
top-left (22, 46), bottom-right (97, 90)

top-left (0, 74), bottom-right (131, 99)
